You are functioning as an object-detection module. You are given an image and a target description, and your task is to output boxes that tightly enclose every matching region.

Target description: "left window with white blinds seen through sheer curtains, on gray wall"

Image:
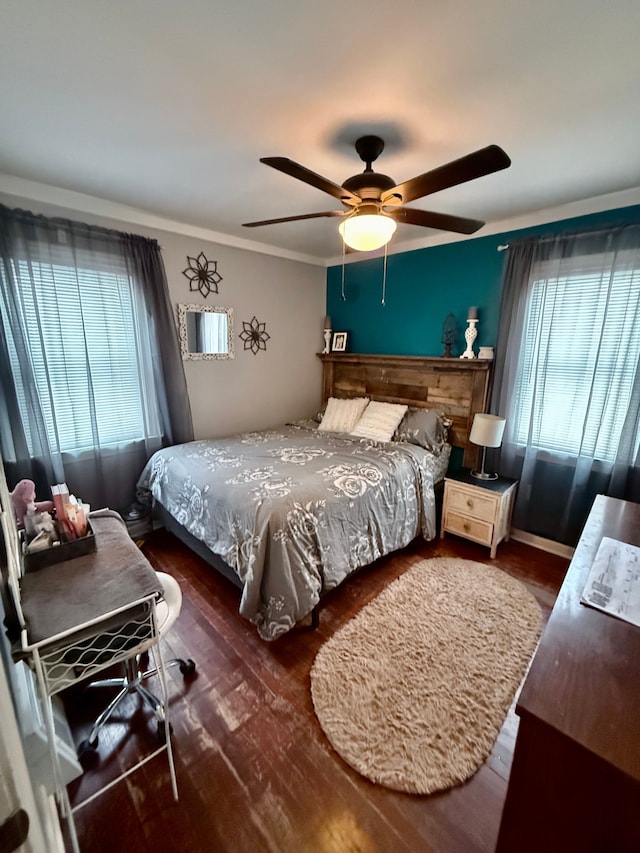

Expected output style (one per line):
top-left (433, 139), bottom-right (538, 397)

top-left (2, 246), bottom-right (160, 453)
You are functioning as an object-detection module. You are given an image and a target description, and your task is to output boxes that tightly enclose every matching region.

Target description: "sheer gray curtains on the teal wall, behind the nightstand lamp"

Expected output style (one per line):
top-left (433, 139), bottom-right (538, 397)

top-left (491, 225), bottom-right (640, 546)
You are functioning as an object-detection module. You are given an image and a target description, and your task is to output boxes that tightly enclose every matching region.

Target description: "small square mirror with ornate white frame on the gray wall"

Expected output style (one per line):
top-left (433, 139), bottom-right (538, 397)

top-left (178, 304), bottom-right (234, 361)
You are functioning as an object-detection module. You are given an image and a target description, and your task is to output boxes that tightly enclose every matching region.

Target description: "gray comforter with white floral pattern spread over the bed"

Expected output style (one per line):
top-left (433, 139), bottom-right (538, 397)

top-left (138, 422), bottom-right (449, 640)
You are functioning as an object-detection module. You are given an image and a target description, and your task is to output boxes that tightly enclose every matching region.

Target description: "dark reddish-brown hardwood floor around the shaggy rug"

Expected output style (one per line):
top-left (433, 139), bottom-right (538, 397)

top-left (66, 530), bottom-right (568, 853)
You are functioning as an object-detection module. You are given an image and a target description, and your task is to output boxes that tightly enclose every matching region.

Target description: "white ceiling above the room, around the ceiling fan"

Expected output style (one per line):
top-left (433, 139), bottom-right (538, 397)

top-left (0, 0), bottom-right (640, 261)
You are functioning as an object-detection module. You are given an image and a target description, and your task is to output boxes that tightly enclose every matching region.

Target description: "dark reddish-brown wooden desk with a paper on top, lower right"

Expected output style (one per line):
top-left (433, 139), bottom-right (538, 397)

top-left (496, 495), bottom-right (640, 853)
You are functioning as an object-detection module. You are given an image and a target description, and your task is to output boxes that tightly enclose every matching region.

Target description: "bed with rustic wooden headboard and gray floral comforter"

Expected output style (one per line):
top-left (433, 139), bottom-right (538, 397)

top-left (138, 354), bottom-right (490, 640)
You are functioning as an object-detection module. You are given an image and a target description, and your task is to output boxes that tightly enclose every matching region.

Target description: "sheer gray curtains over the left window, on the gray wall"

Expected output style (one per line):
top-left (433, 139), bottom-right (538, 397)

top-left (0, 205), bottom-right (193, 512)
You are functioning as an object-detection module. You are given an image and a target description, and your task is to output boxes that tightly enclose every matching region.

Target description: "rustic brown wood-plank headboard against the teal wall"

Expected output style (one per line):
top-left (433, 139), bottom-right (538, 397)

top-left (318, 353), bottom-right (492, 467)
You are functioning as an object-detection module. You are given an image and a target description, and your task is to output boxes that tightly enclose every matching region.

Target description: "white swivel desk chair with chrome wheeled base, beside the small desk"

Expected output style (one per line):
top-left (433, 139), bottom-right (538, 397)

top-left (78, 572), bottom-right (196, 763)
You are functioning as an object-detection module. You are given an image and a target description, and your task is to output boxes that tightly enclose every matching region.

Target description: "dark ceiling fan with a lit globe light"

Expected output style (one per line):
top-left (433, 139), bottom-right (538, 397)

top-left (243, 136), bottom-right (511, 251)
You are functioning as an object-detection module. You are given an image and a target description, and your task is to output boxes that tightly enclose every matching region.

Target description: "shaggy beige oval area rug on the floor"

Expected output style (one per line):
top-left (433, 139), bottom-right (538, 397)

top-left (311, 557), bottom-right (542, 794)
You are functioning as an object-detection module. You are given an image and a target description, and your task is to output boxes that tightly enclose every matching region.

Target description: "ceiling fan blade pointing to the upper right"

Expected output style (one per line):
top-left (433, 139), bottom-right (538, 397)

top-left (382, 145), bottom-right (511, 203)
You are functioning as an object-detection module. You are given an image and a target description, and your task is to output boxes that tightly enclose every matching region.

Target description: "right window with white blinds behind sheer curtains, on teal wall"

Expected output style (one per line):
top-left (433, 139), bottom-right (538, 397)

top-left (511, 253), bottom-right (640, 462)
